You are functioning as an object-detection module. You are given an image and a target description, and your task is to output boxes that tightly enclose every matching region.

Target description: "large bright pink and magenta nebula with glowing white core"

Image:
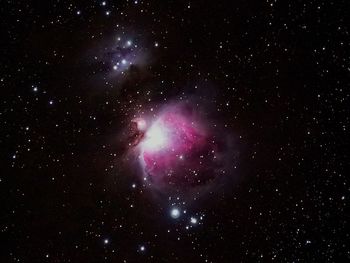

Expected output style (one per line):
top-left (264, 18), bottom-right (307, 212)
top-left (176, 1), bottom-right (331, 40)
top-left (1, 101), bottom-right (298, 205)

top-left (137, 106), bottom-right (221, 189)
